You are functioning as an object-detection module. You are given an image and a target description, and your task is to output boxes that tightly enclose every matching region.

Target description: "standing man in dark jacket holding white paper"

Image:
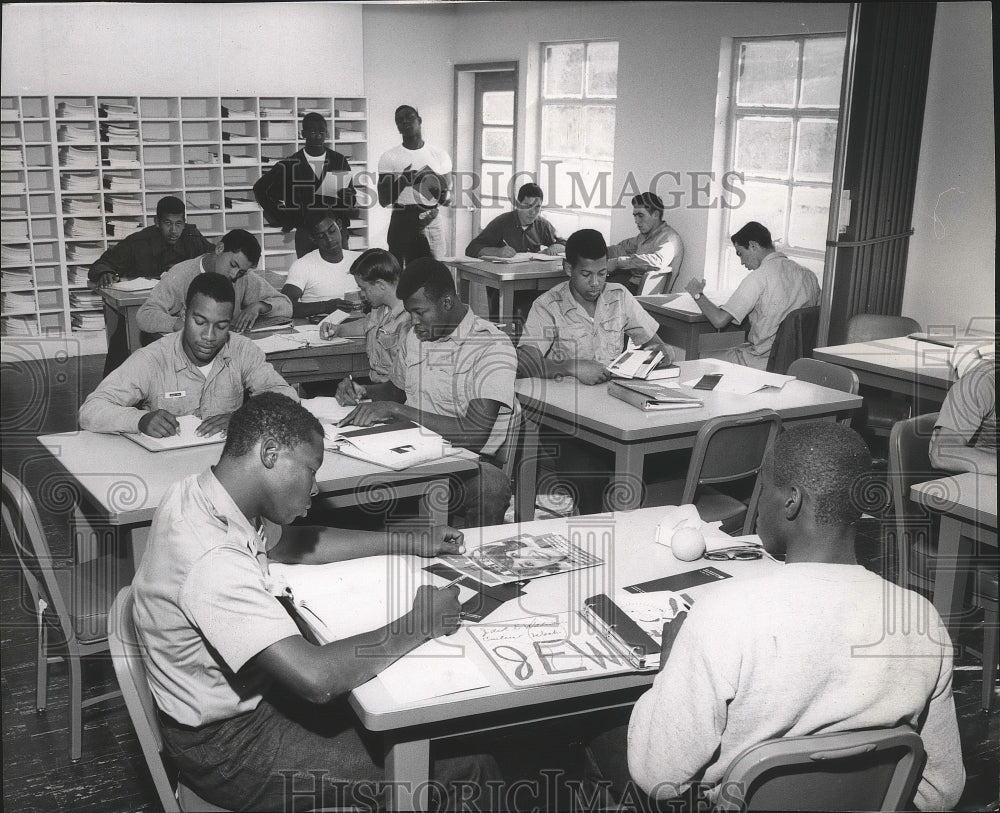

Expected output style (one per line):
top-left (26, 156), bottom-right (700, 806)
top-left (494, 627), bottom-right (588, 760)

top-left (253, 111), bottom-right (357, 257)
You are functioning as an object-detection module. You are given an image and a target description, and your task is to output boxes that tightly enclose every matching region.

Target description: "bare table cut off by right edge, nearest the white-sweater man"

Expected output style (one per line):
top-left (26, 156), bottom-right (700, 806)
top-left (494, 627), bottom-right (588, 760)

top-left (910, 472), bottom-right (1000, 640)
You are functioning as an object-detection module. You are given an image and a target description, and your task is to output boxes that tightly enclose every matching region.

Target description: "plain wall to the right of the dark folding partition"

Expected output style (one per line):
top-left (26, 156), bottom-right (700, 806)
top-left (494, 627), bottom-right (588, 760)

top-left (903, 3), bottom-right (997, 329)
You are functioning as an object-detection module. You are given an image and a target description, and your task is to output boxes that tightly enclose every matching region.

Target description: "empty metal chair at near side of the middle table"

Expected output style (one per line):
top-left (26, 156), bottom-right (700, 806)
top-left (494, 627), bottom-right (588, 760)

top-left (643, 409), bottom-right (781, 534)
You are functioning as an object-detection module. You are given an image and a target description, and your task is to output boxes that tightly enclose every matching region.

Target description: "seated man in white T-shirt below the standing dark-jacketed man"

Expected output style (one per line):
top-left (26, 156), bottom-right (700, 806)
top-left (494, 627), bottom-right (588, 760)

top-left (281, 209), bottom-right (359, 317)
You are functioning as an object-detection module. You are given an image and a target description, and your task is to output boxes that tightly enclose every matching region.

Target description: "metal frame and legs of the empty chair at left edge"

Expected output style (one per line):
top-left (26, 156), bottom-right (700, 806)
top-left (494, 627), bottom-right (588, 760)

top-left (2, 469), bottom-right (121, 762)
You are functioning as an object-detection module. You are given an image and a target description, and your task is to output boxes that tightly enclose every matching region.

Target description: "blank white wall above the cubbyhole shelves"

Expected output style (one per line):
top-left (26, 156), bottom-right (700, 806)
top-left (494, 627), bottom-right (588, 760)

top-left (2, 3), bottom-right (364, 96)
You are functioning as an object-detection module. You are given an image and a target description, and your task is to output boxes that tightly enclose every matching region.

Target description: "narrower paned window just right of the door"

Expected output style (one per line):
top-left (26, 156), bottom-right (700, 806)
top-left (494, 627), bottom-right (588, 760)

top-left (538, 40), bottom-right (618, 233)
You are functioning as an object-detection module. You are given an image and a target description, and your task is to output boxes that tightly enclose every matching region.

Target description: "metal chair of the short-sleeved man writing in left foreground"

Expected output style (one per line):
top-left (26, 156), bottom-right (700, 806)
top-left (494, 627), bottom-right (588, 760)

top-left (108, 587), bottom-right (225, 813)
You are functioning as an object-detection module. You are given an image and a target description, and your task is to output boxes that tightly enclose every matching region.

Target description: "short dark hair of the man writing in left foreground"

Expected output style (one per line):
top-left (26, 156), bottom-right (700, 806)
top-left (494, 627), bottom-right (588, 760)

top-left (222, 392), bottom-right (323, 457)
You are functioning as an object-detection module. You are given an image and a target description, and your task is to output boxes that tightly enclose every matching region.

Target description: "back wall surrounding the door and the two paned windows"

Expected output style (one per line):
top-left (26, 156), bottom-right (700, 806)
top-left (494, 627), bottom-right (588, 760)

top-left (364, 2), bottom-right (849, 279)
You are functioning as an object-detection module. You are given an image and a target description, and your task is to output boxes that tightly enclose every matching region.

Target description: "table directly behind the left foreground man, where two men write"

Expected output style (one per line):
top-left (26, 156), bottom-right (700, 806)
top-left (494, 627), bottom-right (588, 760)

top-left (38, 431), bottom-right (479, 564)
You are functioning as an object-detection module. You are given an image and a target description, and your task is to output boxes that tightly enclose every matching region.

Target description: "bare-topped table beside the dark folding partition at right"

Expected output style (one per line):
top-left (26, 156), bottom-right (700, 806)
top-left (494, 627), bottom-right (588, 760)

top-left (812, 336), bottom-right (954, 404)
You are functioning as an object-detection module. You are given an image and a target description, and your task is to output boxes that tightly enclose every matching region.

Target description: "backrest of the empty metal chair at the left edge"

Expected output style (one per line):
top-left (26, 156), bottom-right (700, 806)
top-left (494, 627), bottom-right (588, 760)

top-left (2, 469), bottom-right (76, 641)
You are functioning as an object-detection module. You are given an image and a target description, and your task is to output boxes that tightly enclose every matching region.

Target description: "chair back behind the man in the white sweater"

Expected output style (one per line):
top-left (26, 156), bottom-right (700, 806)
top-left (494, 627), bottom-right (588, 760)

top-left (716, 725), bottom-right (924, 811)
